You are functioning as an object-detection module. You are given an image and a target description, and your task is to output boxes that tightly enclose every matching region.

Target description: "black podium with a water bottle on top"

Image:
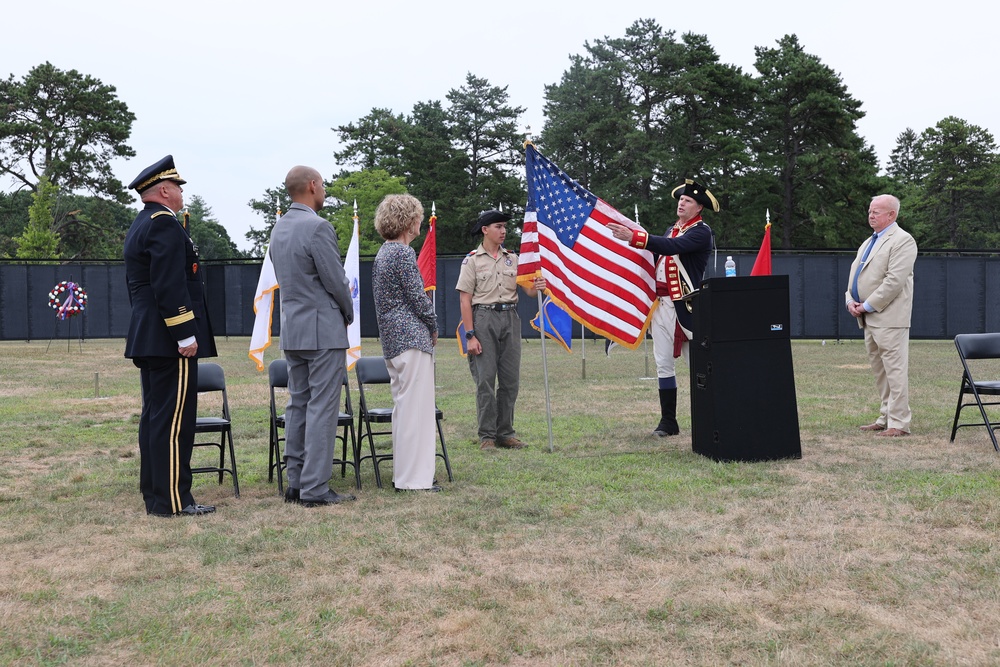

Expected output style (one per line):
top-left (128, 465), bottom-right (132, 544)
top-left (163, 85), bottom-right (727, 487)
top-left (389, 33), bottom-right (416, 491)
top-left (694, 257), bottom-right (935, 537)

top-left (691, 276), bottom-right (802, 461)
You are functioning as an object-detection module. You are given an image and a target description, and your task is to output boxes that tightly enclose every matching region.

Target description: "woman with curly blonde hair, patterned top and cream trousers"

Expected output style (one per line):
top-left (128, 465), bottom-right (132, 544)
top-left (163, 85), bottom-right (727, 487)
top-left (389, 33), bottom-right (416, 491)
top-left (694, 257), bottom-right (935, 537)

top-left (372, 195), bottom-right (441, 491)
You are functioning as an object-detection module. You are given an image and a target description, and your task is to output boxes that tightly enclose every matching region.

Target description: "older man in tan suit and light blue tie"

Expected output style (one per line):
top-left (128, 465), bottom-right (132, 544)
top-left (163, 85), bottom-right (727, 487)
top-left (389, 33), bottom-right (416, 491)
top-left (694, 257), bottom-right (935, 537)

top-left (846, 195), bottom-right (917, 437)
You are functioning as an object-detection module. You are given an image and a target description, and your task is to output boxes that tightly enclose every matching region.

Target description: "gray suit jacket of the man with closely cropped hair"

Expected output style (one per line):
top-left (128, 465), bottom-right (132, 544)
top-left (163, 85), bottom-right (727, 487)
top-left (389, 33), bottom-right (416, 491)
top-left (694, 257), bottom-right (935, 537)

top-left (268, 203), bottom-right (354, 350)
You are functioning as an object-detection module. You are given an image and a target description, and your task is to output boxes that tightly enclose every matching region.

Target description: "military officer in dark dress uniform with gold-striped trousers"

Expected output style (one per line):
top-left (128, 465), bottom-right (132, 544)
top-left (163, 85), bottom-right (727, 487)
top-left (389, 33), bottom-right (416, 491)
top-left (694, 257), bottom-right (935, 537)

top-left (125, 155), bottom-right (216, 517)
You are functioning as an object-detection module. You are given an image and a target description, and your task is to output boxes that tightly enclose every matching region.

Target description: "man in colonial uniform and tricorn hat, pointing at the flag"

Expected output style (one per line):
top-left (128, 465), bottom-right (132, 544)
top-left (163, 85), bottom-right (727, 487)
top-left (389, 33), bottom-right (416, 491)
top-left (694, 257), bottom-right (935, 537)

top-left (608, 179), bottom-right (719, 437)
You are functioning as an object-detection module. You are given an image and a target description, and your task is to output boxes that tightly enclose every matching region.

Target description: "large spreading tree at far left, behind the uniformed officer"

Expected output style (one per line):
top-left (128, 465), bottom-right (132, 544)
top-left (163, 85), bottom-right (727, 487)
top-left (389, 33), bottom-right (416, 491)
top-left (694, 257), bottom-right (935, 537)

top-left (0, 62), bottom-right (135, 203)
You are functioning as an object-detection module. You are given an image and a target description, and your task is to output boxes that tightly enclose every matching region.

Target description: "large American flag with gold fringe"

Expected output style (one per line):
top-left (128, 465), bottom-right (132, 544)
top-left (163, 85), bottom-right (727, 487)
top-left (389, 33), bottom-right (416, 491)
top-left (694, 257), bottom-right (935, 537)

top-left (517, 143), bottom-right (656, 349)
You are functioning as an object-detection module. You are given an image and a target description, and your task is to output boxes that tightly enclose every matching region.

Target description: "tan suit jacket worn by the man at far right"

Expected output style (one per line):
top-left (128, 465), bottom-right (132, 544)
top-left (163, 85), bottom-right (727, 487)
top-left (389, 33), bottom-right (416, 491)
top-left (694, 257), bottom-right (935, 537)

top-left (845, 224), bottom-right (917, 329)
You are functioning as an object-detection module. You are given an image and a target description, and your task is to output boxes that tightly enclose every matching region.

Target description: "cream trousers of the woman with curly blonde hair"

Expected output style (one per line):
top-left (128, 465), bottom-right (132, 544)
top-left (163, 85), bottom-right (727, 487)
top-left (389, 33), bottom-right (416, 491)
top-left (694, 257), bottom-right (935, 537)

top-left (385, 348), bottom-right (437, 489)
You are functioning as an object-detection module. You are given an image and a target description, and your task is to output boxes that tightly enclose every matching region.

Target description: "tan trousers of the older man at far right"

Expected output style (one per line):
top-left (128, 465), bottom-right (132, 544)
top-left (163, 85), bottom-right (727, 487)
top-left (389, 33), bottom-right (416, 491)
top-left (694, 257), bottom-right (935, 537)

top-left (865, 326), bottom-right (913, 433)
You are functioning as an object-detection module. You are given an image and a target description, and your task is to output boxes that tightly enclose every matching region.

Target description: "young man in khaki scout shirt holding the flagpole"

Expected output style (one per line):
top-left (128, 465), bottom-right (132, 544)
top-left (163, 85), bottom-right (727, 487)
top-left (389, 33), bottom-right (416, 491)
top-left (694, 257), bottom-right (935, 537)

top-left (455, 209), bottom-right (545, 450)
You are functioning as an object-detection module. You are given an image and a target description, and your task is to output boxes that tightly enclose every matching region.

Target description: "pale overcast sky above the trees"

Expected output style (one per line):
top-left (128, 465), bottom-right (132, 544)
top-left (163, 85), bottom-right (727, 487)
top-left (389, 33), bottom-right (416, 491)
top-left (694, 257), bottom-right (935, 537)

top-left (0, 0), bottom-right (1000, 249)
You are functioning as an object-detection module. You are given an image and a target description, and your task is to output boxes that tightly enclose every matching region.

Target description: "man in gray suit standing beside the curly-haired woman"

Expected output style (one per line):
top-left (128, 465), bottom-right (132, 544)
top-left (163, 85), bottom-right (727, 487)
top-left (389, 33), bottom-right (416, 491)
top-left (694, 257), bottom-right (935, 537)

top-left (268, 166), bottom-right (354, 507)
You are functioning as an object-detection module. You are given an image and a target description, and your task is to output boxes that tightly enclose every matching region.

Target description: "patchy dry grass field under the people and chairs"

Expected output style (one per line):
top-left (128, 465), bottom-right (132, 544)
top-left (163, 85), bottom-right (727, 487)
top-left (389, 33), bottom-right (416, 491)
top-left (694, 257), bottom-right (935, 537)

top-left (0, 338), bottom-right (1000, 666)
